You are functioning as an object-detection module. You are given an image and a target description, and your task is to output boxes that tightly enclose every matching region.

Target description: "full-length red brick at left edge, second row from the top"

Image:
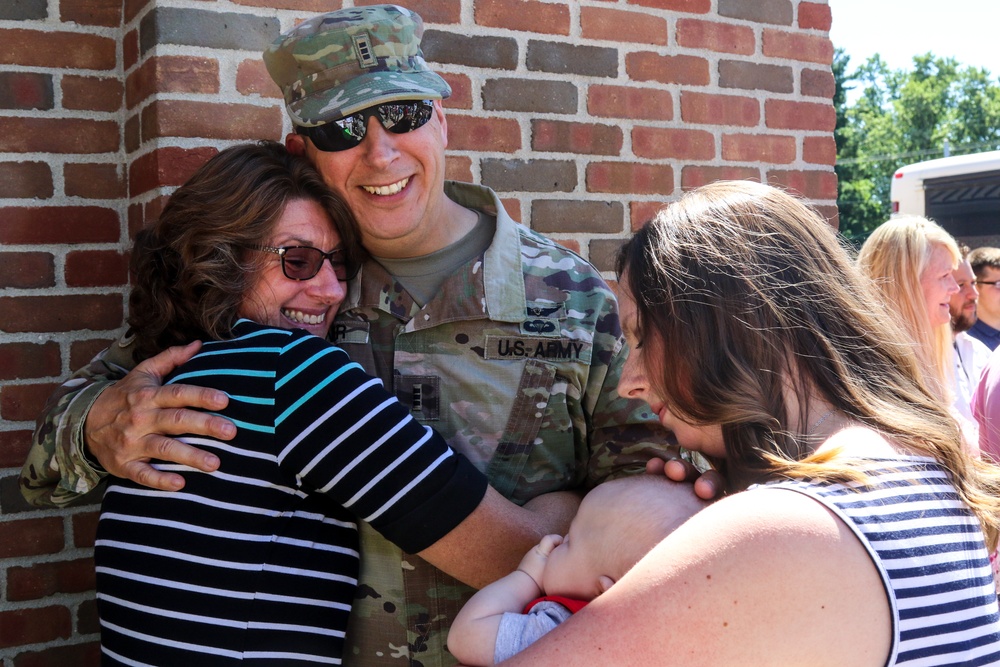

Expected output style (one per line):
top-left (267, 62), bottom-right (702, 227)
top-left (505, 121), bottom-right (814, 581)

top-left (0, 29), bottom-right (117, 70)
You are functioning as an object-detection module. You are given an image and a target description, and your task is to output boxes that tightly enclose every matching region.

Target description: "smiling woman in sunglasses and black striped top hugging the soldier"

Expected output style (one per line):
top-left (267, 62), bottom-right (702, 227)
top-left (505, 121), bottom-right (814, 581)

top-left (95, 142), bottom-right (501, 665)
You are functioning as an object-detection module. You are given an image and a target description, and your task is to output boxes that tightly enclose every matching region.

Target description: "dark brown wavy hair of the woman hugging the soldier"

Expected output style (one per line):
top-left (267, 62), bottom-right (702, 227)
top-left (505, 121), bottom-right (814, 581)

top-left (128, 141), bottom-right (361, 361)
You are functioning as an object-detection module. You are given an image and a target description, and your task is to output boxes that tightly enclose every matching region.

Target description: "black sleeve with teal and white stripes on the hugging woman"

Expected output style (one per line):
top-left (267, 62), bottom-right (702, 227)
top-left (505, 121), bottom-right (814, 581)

top-left (275, 332), bottom-right (486, 553)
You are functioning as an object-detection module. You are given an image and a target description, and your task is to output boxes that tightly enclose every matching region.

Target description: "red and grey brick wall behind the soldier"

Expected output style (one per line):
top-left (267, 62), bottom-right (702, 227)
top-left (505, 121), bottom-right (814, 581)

top-left (0, 0), bottom-right (837, 667)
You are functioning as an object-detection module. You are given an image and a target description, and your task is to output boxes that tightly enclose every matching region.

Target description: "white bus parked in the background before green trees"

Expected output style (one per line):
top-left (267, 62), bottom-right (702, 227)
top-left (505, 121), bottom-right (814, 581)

top-left (890, 151), bottom-right (1000, 248)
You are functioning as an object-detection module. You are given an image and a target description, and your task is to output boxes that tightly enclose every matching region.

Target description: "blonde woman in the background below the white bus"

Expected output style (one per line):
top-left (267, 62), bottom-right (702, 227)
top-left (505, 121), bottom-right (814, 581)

top-left (858, 216), bottom-right (979, 452)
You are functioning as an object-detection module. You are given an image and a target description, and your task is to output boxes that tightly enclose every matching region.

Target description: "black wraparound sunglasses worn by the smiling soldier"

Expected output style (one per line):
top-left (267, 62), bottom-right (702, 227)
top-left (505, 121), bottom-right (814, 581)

top-left (295, 100), bottom-right (434, 152)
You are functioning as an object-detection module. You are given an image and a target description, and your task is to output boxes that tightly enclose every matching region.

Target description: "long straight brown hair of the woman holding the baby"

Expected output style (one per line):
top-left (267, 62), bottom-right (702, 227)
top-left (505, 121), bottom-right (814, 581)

top-left (618, 181), bottom-right (1000, 544)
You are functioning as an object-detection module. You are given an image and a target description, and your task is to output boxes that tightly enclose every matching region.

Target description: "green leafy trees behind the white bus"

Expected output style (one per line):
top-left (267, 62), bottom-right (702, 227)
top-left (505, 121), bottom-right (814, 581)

top-left (833, 49), bottom-right (1000, 239)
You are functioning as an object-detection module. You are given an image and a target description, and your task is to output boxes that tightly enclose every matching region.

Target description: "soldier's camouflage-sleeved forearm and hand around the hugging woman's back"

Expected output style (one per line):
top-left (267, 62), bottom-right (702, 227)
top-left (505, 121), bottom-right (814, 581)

top-left (21, 343), bottom-right (236, 506)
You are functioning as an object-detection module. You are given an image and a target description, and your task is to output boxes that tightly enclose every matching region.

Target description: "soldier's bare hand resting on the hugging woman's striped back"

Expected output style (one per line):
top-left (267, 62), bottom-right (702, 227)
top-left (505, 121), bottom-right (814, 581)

top-left (84, 342), bottom-right (236, 491)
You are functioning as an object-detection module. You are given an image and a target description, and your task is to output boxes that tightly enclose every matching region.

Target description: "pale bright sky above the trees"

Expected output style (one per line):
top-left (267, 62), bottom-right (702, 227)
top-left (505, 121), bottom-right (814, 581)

top-left (829, 0), bottom-right (1000, 76)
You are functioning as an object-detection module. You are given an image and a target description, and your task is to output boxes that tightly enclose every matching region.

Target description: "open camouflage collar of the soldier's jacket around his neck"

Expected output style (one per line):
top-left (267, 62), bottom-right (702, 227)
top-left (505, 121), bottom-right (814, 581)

top-left (341, 181), bottom-right (526, 330)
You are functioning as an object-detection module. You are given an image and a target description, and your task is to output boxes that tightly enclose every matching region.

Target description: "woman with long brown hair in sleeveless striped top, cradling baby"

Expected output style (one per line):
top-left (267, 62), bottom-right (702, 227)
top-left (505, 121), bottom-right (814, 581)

top-left (494, 182), bottom-right (1000, 667)
